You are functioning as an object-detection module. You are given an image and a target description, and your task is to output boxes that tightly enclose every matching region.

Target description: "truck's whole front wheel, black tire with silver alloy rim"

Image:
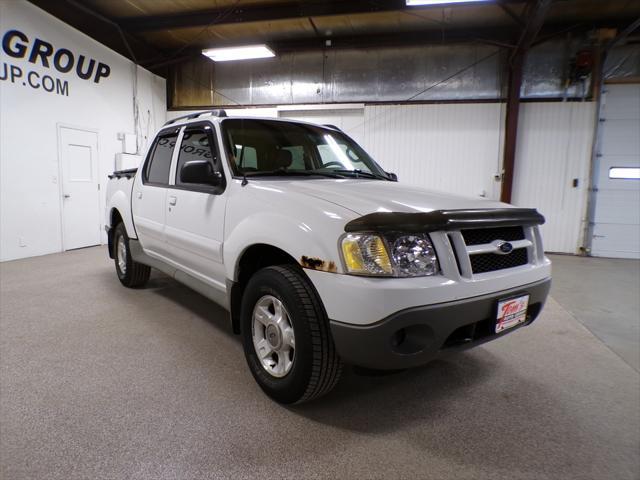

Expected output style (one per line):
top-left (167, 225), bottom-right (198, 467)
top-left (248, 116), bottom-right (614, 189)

top-left (241, 265), bottom-right (342, 404)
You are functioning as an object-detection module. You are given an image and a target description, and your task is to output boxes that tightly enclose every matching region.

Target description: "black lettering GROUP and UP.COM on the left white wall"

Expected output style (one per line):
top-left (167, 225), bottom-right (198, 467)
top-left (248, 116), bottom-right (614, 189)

top-left (0, 30), bottom-right (111, 96)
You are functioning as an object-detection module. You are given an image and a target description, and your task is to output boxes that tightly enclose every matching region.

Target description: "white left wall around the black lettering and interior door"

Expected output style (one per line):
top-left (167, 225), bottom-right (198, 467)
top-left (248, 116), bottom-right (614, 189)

top-left (0, 0), bottom-right (166, 260)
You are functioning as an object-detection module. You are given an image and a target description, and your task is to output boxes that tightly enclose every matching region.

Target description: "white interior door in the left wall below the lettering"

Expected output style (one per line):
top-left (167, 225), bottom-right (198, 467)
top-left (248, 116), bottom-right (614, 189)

top-left (58, 127), bottom-right (100, 250)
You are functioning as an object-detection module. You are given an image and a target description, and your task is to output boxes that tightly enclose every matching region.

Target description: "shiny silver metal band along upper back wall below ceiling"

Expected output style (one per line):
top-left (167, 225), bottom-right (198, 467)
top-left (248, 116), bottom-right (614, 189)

top-left (171, 38), bottom-right (616, 108)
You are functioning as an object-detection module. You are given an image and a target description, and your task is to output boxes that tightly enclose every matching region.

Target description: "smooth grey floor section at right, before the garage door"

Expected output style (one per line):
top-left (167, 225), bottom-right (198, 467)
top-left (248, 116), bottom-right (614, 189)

top-left (549, 255), bottom-right (640, 371)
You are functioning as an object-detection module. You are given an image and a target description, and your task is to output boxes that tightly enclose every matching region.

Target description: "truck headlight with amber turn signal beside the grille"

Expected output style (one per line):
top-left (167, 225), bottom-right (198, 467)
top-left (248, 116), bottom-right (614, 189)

top-left (340, 233), bottom-right (439, 277)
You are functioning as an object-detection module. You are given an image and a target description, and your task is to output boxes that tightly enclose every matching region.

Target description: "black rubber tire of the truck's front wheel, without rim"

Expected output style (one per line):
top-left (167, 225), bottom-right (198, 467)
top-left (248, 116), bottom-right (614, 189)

top-left (241, 265), bottom-right (342, 404)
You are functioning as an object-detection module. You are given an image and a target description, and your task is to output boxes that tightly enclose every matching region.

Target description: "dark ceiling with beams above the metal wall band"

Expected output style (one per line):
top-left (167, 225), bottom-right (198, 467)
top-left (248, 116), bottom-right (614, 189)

top-left (31, 0), bottom-right (640, 73)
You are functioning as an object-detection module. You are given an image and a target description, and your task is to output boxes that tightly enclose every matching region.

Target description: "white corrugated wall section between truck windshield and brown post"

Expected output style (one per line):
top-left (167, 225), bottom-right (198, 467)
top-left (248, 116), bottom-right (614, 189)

top-left (364, 103), bottom-right (504, 202)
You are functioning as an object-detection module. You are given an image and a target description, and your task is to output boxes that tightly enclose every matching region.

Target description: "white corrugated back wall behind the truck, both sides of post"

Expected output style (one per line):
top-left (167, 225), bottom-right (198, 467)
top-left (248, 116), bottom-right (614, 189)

top-left (169, 102), bottom-right (595, 253)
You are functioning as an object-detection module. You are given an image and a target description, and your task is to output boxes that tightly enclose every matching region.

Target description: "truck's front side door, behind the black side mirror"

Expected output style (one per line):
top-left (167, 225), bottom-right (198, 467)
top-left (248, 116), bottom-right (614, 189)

top-left (165, 123), bottom-right (226, 290)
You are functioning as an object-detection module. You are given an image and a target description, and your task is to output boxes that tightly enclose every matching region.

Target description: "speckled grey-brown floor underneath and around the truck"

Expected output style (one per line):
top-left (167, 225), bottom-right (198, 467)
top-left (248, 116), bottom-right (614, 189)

top-left (0, 248), bottom-right (640, 480)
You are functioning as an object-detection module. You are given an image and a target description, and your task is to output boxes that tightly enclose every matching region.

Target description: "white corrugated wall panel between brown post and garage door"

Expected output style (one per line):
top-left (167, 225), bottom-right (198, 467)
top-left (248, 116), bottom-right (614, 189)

top-left (513, 102), bottom-right (595, 253)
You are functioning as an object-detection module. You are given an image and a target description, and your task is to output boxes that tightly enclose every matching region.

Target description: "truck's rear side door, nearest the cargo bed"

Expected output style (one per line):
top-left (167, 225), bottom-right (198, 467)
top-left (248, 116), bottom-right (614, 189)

top-left (131, 128), bottom-right (179, 258)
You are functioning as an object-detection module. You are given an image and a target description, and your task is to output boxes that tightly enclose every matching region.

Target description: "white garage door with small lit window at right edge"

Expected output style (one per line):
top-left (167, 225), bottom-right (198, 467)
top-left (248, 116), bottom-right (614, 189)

top-left (591, 84), bottom-right (640, 258)
